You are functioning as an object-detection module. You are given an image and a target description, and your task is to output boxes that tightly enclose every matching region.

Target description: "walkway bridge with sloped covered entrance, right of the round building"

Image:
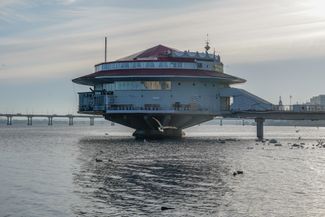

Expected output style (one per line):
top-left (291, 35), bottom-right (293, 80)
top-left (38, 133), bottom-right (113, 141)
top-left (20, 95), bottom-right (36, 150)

top-left (220, 88), bottom-right (325, 140)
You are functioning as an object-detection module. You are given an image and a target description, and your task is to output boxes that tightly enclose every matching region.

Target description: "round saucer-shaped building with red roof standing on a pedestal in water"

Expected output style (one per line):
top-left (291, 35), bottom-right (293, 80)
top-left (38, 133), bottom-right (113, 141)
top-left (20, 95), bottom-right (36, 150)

top-left (73, 44), bottom-right (268, 138)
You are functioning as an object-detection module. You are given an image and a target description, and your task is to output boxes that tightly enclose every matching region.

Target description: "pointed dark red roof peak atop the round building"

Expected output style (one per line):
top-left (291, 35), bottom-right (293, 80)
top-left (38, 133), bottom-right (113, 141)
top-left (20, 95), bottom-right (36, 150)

top-left (117, 45), bottom-right (178, 61)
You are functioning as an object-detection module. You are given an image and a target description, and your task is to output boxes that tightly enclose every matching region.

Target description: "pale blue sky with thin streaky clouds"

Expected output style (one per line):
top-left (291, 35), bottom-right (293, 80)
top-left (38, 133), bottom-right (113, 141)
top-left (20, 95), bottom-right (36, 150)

top-left (0, 0), bottom-right (325, 114)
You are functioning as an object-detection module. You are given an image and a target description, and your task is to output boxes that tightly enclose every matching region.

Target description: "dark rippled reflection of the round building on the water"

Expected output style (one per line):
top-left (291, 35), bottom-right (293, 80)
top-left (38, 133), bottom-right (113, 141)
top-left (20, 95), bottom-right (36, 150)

top-left (74, 138), bottom-right (231, 216)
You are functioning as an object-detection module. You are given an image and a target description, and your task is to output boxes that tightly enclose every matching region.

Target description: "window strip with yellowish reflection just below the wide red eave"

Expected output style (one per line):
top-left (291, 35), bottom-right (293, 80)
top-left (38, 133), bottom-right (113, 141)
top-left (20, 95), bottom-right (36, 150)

top-left (103, 81), bottom-right (172, 91)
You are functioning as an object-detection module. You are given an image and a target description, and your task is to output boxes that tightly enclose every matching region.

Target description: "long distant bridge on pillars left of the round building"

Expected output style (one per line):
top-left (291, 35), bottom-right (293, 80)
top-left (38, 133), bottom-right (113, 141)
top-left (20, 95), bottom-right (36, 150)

top-left (0, 113), bottom-right (103, 126)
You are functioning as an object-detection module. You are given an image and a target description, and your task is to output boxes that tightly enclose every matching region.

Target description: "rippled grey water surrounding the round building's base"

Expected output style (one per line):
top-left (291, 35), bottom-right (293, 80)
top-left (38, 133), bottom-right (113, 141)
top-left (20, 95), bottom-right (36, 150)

top-left (0, 125), bottom-right (325, 217)
